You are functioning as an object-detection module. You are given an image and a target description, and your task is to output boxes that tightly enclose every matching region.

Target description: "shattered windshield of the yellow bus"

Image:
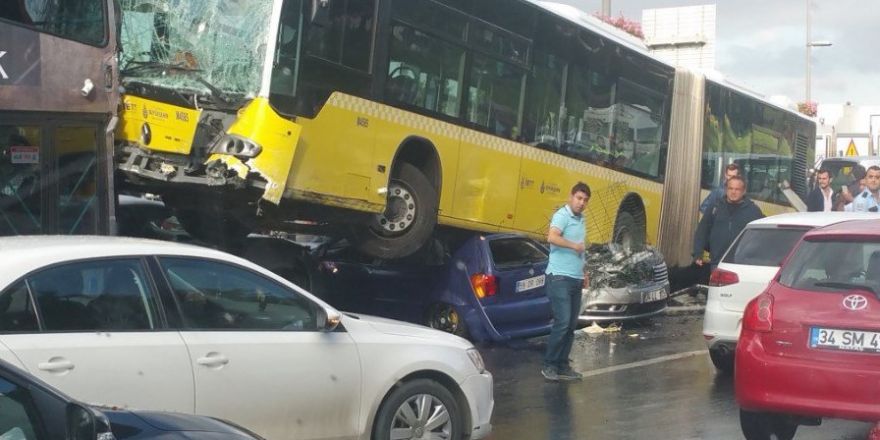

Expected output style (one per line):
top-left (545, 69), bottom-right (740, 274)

top-left (120, 0), bottom-right (273, 100)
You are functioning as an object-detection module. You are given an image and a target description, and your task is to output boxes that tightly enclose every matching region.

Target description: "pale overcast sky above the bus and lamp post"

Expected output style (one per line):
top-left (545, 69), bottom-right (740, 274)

top-left (555, 0), bottom-right (880, 105)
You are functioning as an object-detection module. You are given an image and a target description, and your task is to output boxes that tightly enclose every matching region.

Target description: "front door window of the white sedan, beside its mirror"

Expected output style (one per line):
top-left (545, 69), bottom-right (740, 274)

top-left (159, 257), bottom-right (317, 331)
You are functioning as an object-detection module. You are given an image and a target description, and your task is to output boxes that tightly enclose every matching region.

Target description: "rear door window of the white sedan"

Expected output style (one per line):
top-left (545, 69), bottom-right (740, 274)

top-left (28, 258), bottom-right (159, 331)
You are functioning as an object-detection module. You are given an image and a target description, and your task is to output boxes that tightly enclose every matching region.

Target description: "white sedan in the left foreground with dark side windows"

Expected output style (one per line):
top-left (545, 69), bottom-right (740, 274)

top-left (0, 237), bottom-right (494, 440)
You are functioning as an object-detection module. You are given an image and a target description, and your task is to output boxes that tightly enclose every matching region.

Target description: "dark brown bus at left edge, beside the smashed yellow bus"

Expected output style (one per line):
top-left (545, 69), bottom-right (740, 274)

top-left (0, 0), bottom-right (119, 235)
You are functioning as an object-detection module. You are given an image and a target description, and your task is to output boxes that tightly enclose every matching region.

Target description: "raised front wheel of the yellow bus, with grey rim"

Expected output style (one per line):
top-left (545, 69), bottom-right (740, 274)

top-left (356, 162), bottom-right (437, 259)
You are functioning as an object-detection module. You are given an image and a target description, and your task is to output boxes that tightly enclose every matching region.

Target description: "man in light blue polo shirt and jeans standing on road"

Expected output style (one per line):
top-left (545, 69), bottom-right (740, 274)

top-left (541, 182), bottom-right (590, 381)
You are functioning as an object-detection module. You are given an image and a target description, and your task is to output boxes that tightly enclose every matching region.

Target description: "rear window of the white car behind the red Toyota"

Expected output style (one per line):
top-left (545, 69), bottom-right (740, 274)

top-left (721, 228), bottom-right (809, 267)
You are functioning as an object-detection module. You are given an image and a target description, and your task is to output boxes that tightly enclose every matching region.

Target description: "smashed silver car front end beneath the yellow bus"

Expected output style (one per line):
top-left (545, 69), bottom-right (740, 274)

top-left (580, 244), bottom-right (670, 323)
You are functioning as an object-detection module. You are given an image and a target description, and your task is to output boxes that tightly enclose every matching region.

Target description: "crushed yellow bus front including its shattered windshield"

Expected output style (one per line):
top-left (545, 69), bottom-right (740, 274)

top-left (116, 0), bottom-right (301, 204)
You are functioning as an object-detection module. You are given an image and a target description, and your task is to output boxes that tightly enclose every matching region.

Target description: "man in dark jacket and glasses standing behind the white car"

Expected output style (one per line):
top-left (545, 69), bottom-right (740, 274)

top-left (694, 176), bottom-right (764, 268)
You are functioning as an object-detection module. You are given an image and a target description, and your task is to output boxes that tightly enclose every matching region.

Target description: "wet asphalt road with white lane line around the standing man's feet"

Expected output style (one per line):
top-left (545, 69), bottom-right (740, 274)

top-left (480, 313), bottom-right (871, 440)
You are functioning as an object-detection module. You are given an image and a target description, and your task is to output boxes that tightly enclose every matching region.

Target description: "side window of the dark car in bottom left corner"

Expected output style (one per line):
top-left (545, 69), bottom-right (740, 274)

top-left (0, 377), bottom-right (42, 440)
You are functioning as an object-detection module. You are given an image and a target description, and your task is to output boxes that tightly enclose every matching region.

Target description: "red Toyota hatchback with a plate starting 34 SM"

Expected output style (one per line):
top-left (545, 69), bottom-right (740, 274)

top-left (734, 220), bottom-right (880, 440)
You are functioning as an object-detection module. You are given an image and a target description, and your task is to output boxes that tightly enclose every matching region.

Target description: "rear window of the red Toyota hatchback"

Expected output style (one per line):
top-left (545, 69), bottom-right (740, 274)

top-left (779, 240), bottom-right (880, 292)
